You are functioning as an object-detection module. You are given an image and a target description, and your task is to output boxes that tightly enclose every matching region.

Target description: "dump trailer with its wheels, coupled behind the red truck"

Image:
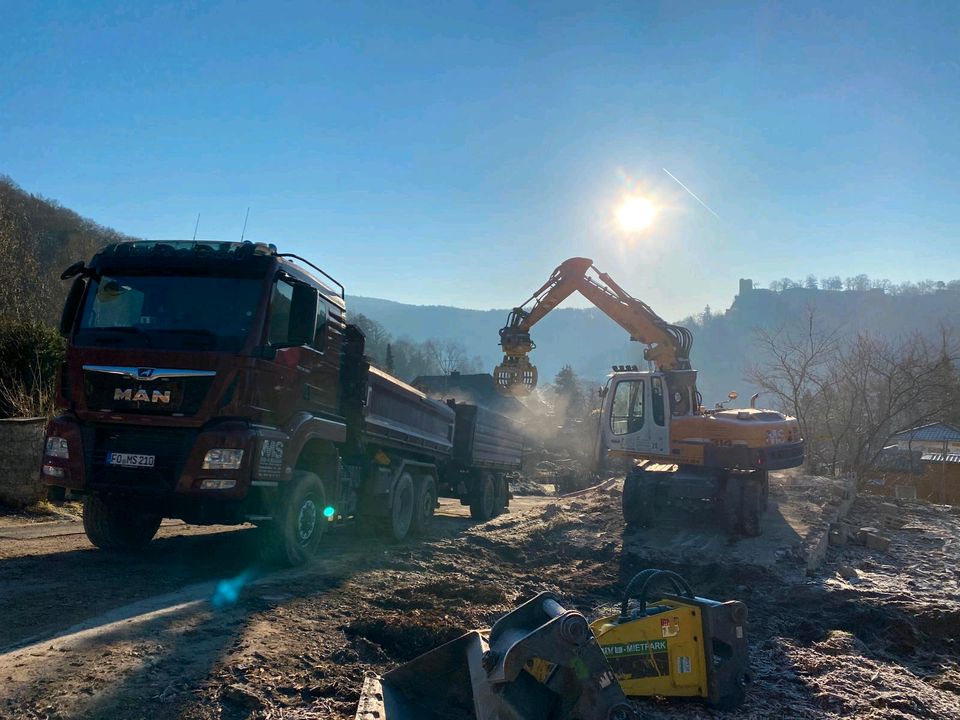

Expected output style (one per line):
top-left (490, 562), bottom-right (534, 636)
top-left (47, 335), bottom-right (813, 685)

top-left (440, 400), bottom-right (523, 521)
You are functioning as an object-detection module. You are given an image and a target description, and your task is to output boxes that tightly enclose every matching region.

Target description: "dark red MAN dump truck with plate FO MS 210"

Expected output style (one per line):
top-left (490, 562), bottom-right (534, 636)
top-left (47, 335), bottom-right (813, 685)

top-left (42, 241), bottom-right (524, 564)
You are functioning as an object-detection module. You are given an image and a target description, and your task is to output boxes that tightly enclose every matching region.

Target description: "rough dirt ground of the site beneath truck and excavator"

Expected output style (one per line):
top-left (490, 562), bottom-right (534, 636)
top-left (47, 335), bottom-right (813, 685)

top-left (0, 478), bottom-right (960, 720)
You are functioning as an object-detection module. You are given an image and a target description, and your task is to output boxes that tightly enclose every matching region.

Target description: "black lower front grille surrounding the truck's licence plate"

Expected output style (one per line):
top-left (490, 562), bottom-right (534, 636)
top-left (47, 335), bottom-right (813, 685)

top-left (83, 424), bottom-right (197, 492)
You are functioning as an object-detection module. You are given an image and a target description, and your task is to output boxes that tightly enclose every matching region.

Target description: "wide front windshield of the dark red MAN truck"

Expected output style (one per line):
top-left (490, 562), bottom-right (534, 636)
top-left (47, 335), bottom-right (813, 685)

top-left (75, 275), bottom-right (263, 352)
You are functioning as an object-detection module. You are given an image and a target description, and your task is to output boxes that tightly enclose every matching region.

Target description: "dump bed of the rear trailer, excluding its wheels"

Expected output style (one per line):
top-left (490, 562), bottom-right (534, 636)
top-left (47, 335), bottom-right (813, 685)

top-left (453, 403), bottom-right (523, 471)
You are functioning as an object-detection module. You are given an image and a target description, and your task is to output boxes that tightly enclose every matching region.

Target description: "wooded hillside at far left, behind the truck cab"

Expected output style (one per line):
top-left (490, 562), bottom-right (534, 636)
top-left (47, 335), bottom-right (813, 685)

top-left (0, 175), bottom-right (133, 323)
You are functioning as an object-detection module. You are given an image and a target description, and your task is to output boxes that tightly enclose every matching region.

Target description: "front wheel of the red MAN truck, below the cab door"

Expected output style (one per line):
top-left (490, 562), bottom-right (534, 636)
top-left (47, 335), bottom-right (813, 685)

top-left (261, 470), bottom-right (327, 567)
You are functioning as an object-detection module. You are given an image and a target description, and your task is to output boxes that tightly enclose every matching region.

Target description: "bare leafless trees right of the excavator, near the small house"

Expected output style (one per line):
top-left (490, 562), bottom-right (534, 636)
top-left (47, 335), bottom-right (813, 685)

top-left (748, 308), bottom-right (960, 479)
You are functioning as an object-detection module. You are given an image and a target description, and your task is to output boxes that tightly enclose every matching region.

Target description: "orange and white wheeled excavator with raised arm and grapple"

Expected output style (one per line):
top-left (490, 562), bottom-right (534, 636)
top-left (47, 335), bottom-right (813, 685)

top-left (494, 258), bottom-right (803, 537)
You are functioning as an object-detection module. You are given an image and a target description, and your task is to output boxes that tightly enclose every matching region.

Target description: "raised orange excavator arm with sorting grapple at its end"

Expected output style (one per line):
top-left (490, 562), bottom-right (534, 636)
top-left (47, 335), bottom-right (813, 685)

top-left (493, 258), bottom-right (693, 395)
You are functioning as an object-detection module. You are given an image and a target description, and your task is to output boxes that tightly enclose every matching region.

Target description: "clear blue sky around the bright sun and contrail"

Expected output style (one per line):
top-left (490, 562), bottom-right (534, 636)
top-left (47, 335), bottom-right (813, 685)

top-left (0, 1), bottom-right (960, 319)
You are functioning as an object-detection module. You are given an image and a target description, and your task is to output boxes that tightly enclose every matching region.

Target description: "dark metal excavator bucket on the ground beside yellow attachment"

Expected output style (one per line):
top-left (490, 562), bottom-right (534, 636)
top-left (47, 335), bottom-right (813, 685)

top-left (356, 593), bottom-right (639, 720)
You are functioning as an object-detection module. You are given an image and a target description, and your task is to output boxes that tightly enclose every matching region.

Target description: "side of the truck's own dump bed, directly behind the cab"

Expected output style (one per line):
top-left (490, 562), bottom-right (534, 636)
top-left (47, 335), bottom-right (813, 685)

top-left (363, 367), bottom-right (455, 457)
